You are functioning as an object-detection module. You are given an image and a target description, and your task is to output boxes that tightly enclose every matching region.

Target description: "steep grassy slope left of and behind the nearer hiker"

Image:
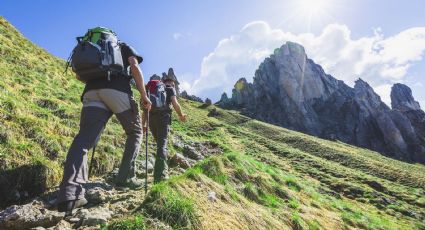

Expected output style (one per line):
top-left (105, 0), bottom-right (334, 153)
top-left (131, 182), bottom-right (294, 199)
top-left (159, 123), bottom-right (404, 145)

top-left (0, 17), bottom-right (128, 203)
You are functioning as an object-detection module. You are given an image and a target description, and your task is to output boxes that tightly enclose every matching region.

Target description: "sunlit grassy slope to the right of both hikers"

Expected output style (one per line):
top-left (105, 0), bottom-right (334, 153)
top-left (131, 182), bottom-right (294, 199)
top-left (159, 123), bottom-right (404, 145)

top-left (118, 101), bottom-right (425, 229)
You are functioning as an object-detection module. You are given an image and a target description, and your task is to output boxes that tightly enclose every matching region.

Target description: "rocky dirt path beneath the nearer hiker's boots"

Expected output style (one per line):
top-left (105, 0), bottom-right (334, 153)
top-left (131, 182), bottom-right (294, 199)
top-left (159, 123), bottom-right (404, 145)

top-left (0, 173), bottom-right (151, 230)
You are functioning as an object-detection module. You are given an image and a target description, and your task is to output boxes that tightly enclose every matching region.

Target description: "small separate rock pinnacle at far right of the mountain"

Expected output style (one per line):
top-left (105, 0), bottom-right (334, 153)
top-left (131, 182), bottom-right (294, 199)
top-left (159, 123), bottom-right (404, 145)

top-left (391, 83), bottom-right (421, 112)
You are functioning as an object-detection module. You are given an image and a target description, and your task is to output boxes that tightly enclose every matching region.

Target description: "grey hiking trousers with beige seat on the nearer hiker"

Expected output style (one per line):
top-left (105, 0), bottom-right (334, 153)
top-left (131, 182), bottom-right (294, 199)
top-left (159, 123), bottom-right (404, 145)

top-left (58, 89), bottom-right (142, 202)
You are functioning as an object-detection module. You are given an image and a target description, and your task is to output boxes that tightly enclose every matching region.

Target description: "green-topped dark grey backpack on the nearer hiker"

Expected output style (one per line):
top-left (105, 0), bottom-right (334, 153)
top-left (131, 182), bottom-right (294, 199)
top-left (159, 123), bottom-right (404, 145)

top-left (67, 27), bottom-right (128, 82)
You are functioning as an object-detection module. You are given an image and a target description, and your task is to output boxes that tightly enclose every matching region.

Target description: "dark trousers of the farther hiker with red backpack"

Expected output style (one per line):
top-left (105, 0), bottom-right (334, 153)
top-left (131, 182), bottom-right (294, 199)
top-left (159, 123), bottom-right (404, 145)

top-left (149, 112), bottom-right (171, 183)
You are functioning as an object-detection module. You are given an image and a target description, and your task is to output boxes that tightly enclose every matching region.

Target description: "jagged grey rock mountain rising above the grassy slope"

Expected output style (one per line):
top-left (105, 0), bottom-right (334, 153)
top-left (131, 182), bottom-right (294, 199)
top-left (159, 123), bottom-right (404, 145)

top-left (217, 42), bottom-right (425, 163)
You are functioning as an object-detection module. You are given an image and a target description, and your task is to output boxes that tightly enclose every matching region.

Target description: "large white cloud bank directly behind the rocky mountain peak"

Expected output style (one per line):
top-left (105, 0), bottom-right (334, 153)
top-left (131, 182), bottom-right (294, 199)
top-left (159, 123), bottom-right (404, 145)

top-left (191, 21), bottom-right (425, 100)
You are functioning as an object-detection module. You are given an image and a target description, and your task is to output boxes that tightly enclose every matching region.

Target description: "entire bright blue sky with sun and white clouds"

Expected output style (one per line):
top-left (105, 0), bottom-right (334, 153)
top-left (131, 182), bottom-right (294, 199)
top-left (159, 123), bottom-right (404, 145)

top-left (0, 0), bottom-right (425, 107)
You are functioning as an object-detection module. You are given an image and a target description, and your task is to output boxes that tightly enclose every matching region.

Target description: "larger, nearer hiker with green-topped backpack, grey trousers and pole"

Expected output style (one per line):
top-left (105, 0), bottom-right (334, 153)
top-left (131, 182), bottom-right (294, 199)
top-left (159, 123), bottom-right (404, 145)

top-left (57, 27), bottom-right (151, 215)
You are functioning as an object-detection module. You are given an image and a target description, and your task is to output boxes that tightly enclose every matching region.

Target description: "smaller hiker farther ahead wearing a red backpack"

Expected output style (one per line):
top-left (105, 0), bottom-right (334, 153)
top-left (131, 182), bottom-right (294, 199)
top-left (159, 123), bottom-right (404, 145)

top-left (143, 74), bottom-right (187, 183)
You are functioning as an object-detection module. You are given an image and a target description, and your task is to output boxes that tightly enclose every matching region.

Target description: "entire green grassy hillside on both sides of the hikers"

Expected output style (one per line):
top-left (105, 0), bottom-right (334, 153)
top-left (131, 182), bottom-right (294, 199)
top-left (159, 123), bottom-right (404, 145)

top-left (0, 18), bottom-right (425, 229)
